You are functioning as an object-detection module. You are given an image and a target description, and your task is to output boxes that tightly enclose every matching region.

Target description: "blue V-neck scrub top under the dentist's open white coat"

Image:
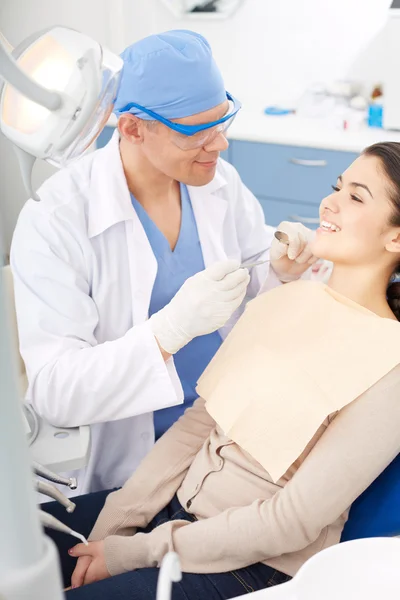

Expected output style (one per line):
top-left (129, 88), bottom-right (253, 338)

top-left (131, 184), bottom-right (222, 439)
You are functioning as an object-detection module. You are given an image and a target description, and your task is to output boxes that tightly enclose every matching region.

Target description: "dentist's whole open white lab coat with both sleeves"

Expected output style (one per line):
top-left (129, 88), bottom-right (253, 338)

top-left (11, 132), bottom-right (278, 493)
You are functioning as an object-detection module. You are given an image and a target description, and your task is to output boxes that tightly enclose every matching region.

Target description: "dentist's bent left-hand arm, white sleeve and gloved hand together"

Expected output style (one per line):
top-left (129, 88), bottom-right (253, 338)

top-left (11, 203), bottom-right (249, 427)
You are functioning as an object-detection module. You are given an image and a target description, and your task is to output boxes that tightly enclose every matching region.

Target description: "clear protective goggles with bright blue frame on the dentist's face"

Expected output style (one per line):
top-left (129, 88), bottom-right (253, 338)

top-left (119, 92), bottom-right (242, 150)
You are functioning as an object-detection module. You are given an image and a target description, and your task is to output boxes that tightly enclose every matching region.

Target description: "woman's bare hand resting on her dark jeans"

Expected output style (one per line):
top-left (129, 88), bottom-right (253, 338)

top-left (68, 541), bottom-right (111, 588)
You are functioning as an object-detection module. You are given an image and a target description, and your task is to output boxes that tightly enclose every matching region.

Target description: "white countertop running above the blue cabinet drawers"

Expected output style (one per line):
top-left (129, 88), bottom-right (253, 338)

top-left (228, 109), bottom-right (400, 153)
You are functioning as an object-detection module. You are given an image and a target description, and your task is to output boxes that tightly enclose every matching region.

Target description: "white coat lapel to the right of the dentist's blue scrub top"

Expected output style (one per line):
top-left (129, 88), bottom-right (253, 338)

top-left (188, 174), bottom-right (228, 267)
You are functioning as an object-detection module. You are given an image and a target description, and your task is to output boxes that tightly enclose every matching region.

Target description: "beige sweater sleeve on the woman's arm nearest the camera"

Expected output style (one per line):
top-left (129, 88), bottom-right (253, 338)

top-left (105, 366), bottom-right (400, 574)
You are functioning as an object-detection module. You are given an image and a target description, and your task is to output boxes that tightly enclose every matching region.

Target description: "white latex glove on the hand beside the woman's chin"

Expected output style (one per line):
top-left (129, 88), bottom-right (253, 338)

top-left (270, 221), bottom-right (318, 283)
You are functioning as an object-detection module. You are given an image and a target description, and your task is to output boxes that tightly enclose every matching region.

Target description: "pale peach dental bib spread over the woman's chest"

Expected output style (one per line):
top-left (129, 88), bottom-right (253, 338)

top-left (197, 281), bottom-right (400, 482)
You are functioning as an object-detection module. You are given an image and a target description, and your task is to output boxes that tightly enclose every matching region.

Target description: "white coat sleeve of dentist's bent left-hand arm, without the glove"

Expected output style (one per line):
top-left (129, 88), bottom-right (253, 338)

top-left (11, 221), bottom-right (183, 427)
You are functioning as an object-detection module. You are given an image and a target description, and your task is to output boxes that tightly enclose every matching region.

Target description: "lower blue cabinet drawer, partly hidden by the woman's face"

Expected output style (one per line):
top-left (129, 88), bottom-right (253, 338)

top-left (258, 198), bottom-right (319, 229)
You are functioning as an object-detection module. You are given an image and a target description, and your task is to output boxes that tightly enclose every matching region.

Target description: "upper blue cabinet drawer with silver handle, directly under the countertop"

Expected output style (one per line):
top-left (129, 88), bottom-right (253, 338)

top-left (229, 140), bottom-right (358, 205)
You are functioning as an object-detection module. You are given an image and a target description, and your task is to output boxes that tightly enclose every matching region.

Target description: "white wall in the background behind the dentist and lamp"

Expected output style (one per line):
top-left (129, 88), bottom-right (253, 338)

top-left (0, 0), bottom-right (390, 251)
